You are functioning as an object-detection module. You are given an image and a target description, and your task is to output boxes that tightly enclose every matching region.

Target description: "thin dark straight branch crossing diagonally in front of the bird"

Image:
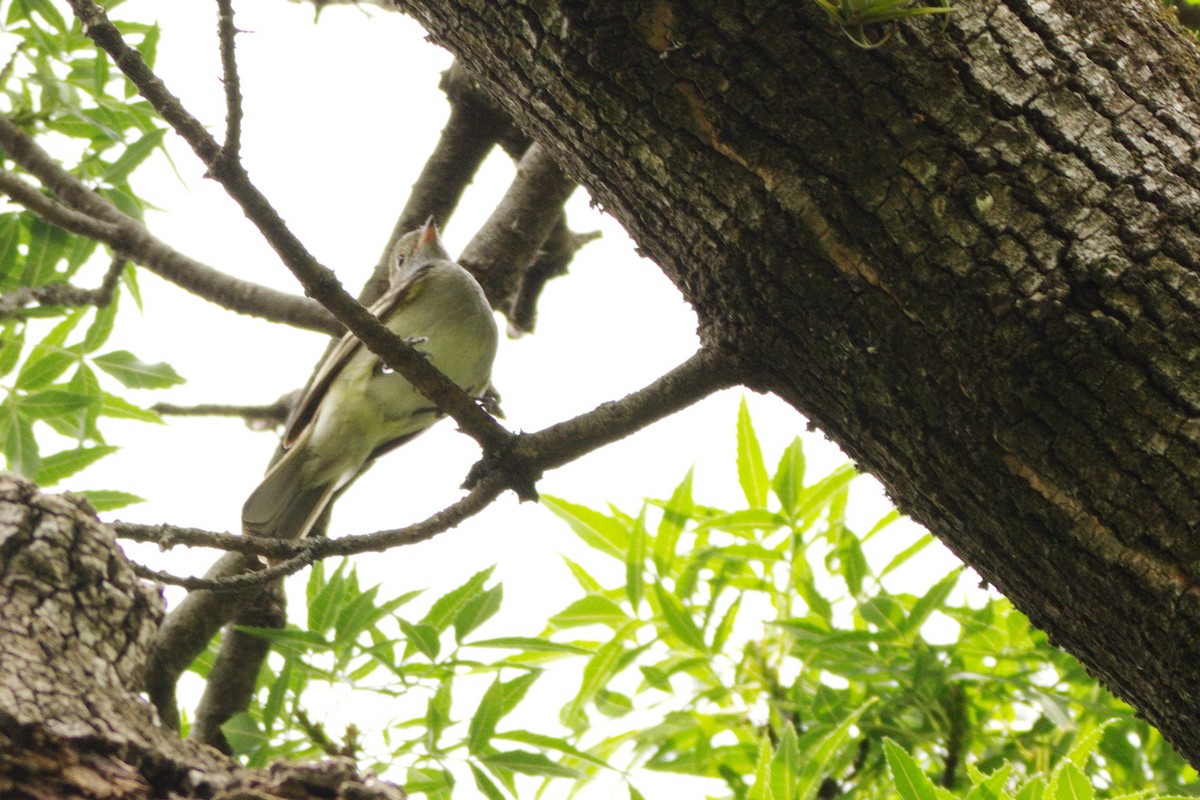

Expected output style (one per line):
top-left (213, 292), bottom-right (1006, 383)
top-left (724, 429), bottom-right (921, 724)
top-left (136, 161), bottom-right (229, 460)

top-left (70, 0), bottom-right (512, 451)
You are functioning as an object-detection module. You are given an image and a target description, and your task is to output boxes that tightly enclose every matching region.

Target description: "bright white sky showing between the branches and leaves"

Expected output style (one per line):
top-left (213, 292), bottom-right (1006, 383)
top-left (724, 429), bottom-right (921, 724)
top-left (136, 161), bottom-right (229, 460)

top-left (21, 0), bottom-right (954, 796)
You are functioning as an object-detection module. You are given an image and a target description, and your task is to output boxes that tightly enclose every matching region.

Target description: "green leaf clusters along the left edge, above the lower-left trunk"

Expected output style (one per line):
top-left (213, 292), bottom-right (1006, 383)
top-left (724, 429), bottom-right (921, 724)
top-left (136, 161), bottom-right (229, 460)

top-left (0, 0), bottom-right (175, 510)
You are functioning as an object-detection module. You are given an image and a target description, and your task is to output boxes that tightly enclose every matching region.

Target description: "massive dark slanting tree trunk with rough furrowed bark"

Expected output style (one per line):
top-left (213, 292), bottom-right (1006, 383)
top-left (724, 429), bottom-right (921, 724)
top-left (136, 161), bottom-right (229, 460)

top-left (402, 0), bottom-right (1200, 765)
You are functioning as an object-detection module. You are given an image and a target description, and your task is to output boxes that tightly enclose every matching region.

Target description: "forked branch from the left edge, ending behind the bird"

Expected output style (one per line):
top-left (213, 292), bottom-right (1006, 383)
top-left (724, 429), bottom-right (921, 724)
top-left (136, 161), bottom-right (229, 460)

top-left (0, 115), bottom-right (344, 335)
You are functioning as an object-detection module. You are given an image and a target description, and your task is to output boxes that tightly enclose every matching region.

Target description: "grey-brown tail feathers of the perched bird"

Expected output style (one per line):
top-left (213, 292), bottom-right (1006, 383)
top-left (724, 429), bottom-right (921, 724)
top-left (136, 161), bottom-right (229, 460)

top-left (241, 446), bottom-right (337, 539)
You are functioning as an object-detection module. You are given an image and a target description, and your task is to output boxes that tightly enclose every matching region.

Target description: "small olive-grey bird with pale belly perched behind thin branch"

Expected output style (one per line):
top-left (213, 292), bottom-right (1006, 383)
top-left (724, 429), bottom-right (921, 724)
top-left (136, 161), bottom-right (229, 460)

top-left (241, 219), bottom-right (497, 539)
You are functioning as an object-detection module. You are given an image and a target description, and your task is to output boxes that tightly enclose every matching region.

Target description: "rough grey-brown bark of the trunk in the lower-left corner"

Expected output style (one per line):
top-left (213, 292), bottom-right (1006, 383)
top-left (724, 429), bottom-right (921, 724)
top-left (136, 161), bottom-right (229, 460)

top-left (0, 473), bottom-right (404, 800)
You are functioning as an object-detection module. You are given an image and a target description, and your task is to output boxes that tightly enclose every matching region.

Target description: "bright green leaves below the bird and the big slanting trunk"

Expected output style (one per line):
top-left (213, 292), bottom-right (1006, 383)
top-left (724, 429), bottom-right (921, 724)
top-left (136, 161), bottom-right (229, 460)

top-left (229, 405), bottom-right (1196, 800)
